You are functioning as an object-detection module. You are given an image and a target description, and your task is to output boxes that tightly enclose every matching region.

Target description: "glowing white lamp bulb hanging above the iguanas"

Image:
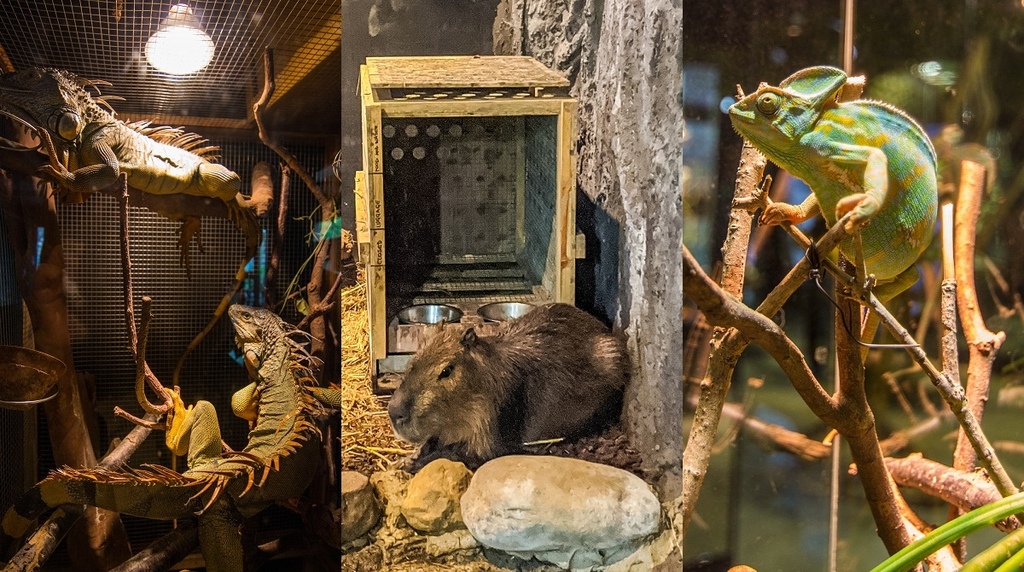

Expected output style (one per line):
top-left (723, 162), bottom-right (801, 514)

top-left (145, 4), bottom-right (213, 76)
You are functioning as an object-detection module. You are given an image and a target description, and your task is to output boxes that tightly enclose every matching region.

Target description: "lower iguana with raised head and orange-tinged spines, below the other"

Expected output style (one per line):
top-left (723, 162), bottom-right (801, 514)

top-left (2, 305), bottom-right (341, 572)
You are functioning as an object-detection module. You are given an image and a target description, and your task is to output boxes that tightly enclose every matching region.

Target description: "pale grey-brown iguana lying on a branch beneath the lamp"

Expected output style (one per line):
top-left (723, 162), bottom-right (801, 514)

top-left (0, 68), bottom-right (261, 271)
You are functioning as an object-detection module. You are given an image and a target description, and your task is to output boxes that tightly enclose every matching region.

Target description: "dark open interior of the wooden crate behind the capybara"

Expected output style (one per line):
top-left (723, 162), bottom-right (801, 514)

top-left (381, 117), bottom-right (556, 315)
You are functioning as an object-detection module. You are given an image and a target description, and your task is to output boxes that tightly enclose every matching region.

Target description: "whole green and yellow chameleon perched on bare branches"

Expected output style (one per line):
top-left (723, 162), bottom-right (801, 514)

top-left (729, 67), bottom-right (938, 295)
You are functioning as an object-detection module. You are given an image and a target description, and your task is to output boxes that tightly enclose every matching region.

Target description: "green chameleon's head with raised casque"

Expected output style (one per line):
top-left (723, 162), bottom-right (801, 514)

top-left (729, 67), bottom-right (847, 151)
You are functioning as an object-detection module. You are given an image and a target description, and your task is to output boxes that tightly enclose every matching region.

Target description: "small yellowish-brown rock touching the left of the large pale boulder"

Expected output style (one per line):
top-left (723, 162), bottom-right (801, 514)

top-left (401, 458), bottom-right (473, 534)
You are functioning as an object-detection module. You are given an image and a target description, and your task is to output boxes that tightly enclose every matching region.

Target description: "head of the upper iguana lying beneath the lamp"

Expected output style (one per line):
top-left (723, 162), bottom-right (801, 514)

top-left (0, 68), bottom-right (114, 143)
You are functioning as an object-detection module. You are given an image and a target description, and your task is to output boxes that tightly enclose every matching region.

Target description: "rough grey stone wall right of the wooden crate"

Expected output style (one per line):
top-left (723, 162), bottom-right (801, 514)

top-left (494, 0), bottom-right (683, 498)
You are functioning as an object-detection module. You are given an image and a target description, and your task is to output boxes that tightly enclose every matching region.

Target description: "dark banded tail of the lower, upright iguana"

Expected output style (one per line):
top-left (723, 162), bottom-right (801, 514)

top-left (2, 465), bottom-right (211, 538)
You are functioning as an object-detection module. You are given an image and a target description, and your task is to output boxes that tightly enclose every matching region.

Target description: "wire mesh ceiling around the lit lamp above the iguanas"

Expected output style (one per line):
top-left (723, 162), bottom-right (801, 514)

top-left (0, 0), bottom-right (341, 120)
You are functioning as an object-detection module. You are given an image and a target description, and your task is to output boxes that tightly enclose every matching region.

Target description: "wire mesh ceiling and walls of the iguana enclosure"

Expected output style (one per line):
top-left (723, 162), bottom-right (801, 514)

top-left (0, 0), bottom-right (341, 567)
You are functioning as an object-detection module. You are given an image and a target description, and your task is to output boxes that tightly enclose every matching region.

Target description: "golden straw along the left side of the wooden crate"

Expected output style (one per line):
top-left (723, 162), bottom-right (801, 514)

top-left (341, 272), bottom-right (412, 476)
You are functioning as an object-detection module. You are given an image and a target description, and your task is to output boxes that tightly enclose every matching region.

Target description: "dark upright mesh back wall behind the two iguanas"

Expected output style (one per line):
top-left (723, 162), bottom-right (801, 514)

top-left (27, 136), bottom-right (326, 547)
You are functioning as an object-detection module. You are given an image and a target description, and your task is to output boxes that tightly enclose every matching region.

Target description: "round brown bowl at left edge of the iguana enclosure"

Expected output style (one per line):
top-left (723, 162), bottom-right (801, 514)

top-left (0, 346), bottom-right (66, 410)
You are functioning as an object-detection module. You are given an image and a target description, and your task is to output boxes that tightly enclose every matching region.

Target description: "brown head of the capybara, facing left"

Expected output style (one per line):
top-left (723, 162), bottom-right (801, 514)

top-left (387, 327), bottom-right (497, 454)
